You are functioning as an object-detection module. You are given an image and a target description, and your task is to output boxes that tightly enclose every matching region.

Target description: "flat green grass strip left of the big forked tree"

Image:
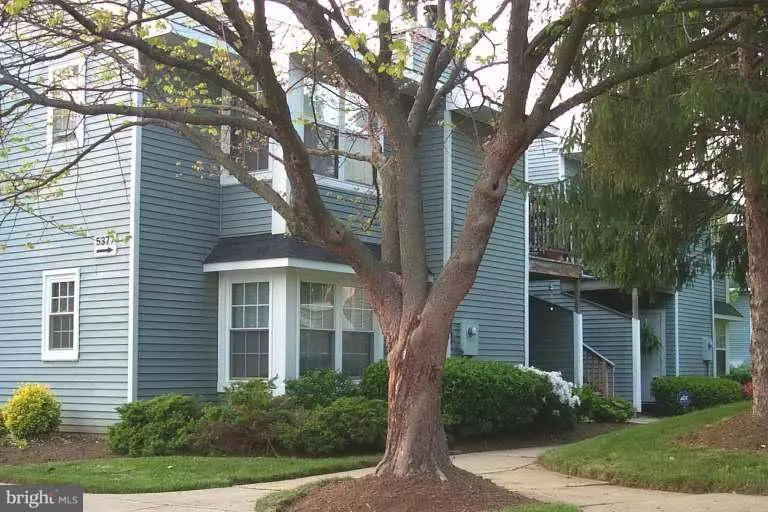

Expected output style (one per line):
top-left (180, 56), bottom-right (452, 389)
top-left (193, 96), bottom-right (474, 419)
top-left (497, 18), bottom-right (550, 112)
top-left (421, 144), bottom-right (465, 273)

top-left (0, 456), bottom-right (379, 493)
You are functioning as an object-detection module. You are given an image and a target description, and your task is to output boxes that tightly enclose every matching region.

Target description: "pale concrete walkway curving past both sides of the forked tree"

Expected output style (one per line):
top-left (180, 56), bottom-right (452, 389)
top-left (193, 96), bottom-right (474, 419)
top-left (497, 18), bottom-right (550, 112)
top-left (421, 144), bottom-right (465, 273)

top-left (85, 448), bottom-right (768, 512)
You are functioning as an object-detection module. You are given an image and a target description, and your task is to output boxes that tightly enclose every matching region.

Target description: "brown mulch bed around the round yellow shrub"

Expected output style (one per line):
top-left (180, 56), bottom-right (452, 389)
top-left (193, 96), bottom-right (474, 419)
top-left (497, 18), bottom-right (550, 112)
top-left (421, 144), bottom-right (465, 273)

top-left (0, 433), bottom-right (113, 464)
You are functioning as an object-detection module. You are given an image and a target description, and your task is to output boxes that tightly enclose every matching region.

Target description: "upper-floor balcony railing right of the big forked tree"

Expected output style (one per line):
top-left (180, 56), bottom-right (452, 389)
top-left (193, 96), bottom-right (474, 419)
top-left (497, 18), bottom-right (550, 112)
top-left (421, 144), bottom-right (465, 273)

top-left (529, 192), bottom-right (577, 263)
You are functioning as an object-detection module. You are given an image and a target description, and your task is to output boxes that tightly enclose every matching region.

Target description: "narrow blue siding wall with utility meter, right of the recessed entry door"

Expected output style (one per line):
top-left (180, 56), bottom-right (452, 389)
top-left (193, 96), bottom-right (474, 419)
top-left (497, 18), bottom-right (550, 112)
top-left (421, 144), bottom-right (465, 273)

top-left (678, 258), bottom-right (712, 375)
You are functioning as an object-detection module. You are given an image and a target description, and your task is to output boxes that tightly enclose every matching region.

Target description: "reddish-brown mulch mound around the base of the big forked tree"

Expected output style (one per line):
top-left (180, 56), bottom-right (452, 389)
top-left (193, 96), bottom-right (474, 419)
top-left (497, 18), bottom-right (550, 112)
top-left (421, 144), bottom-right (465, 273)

top-left (289, 469), bottom-right (531, 512)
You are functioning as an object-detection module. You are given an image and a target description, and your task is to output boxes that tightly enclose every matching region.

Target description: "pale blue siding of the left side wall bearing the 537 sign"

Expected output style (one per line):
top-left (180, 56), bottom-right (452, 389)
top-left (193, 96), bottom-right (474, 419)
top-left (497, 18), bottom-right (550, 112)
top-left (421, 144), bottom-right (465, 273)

top-left (0, 54), bottom-right (133, 431)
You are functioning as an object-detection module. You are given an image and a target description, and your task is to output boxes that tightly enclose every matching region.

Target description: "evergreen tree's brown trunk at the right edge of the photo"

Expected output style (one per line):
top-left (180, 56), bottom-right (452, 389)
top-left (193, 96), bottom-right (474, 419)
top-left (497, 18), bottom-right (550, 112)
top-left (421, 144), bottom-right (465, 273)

top-left (744, 176), bottom-right (768, 425)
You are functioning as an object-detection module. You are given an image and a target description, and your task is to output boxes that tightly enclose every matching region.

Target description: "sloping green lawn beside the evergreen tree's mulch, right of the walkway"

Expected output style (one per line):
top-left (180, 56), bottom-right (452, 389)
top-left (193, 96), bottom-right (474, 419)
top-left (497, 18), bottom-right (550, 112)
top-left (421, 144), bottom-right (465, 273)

top-left (542, 402), bottom-right (768, 494)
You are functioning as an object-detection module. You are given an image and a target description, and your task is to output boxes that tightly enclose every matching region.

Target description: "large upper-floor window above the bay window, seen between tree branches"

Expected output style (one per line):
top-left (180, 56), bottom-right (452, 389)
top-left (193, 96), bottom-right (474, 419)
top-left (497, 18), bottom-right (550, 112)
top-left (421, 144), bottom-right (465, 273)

top-left (304, 82), bottom-right (373, 185)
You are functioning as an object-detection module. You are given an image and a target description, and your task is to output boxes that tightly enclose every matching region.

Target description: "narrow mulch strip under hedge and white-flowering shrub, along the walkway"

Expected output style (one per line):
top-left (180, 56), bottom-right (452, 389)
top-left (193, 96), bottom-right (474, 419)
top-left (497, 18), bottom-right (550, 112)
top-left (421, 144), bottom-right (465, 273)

top-left (451, 423), bottom-right (631, 454)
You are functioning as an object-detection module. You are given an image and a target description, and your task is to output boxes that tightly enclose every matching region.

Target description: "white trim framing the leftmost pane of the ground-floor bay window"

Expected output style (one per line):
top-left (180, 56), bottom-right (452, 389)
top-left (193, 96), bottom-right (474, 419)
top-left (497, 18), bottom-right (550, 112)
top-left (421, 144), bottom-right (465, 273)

top-left (217, 271), bottom-right (285, 392)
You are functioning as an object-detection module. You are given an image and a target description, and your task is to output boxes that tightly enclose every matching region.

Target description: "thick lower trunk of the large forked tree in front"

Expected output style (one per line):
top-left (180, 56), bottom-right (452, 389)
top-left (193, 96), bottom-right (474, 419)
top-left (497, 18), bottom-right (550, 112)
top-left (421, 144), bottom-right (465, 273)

top-left (376, 319), bottom-right (453, 479)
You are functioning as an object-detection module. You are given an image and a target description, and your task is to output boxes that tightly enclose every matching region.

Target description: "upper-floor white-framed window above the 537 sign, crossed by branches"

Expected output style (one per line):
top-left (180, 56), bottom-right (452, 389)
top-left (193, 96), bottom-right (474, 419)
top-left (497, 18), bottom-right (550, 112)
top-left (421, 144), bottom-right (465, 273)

top-left (48, 59), bottom-right (85, 151)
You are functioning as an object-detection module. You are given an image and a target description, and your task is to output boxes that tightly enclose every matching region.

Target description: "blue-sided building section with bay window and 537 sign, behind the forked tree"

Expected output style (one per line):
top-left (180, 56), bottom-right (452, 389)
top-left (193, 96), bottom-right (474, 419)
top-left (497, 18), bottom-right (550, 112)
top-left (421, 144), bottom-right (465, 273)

top-left (0, 22), bottom-right (528, 431)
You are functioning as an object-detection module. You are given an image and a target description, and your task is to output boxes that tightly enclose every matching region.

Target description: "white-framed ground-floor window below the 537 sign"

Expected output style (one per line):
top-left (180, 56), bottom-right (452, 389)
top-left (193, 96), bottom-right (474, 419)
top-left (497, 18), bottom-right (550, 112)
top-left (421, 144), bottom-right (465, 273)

top-left (42, 269), bottom-right (80, 361)
